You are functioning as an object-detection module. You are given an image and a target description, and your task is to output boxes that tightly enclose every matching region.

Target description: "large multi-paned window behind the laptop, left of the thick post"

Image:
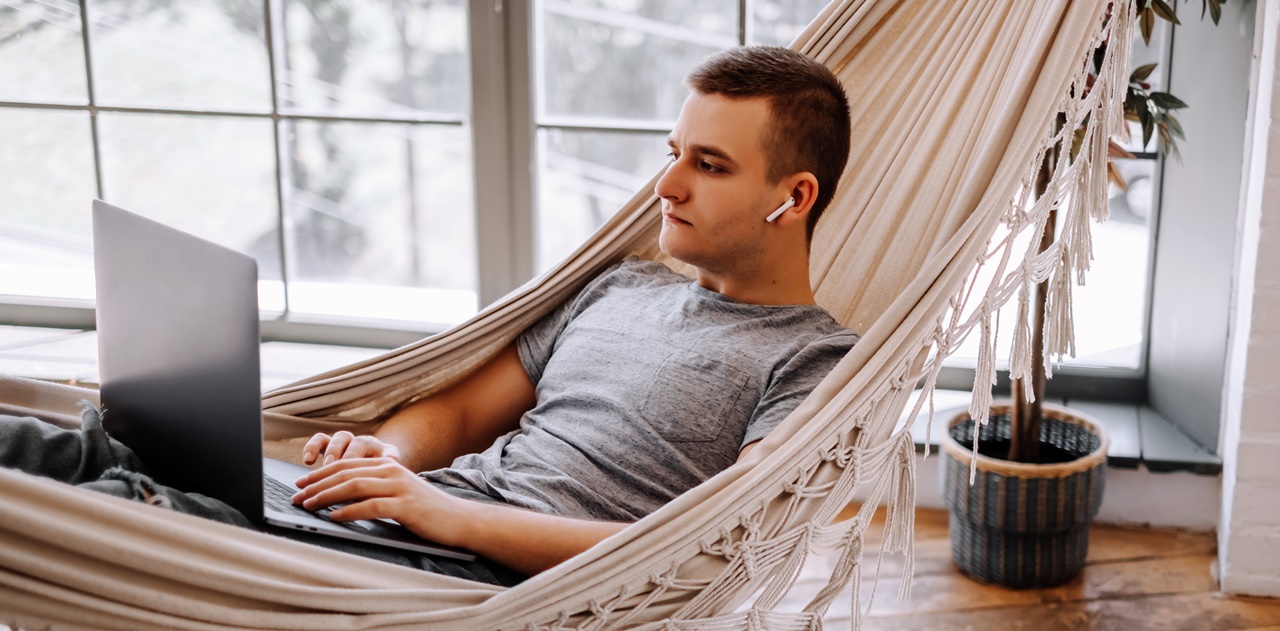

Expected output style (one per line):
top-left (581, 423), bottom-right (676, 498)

top-left (0, 0), bottom-right (477, 328)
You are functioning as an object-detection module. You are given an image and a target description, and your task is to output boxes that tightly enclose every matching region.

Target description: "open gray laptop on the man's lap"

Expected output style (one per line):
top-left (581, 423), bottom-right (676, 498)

top-left (93, 200), bottom-right (475, 561)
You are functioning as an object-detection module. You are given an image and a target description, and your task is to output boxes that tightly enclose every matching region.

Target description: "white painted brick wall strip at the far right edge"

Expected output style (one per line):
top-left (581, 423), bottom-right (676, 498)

top-left (1219, 0), bottom-right (1280, 596)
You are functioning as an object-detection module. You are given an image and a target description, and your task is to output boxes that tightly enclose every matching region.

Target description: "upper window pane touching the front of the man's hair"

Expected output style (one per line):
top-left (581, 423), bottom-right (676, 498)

top-left (536, 0), bottom-right (737, 120)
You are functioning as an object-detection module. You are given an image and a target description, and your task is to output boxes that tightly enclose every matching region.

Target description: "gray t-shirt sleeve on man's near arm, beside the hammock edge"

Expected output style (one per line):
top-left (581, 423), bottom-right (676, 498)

top-left (742, 330), bottom-right (858, 447)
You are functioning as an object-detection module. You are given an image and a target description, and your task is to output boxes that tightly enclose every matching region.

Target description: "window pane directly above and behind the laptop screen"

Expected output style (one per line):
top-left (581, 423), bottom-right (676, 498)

top-left (99, 113), bottom-right (283, 300)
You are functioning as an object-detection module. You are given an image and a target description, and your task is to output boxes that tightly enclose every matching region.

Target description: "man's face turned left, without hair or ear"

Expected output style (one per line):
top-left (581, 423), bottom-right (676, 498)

top-left (654, 92), bottom-right (788, 274)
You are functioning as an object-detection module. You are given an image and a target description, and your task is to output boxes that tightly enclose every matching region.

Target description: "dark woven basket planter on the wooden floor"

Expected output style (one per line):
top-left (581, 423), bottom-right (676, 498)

top-left (943, 403), bottom-right (1107, 587)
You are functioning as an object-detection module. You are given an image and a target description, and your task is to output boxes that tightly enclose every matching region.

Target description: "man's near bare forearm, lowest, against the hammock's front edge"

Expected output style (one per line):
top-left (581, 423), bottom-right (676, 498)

top-left (458, 500), bottom-right (627, 575)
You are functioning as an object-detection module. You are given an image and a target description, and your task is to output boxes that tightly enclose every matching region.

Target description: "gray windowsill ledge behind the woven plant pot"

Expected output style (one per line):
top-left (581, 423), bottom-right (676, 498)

top-left (900, 389), bottom-right (1222, 476)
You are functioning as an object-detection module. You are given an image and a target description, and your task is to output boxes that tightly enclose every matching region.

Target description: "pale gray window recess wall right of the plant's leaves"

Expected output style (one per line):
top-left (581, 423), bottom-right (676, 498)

top-left (1147, 0), bottom-right (1265, 454)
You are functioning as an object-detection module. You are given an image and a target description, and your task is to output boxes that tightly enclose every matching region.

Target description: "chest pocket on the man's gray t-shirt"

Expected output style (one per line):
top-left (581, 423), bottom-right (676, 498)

top-left (640, 351), bottom-right (754, 443)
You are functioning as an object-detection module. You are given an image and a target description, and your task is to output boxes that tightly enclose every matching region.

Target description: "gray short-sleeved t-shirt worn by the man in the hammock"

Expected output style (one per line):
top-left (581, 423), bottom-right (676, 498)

top-left (422, 259), bottom-right (858, 521)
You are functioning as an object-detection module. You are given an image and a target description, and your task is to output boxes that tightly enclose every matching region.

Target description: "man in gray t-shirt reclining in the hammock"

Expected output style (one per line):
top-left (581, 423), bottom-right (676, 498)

top-left (0, 47), bottom-right (858, 584)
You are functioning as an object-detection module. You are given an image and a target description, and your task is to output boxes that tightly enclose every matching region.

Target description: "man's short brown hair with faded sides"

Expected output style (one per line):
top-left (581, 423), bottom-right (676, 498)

top-left (685, 46), bottom-right (850, 238)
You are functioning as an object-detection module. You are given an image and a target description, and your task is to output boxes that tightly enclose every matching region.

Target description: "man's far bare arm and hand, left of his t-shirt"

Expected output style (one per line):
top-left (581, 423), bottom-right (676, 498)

top-left (302, 343), bottom-right (536, 471)
